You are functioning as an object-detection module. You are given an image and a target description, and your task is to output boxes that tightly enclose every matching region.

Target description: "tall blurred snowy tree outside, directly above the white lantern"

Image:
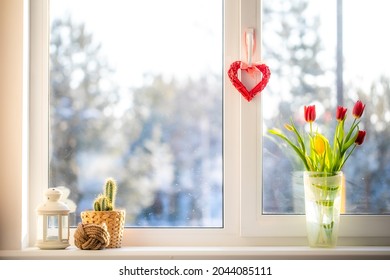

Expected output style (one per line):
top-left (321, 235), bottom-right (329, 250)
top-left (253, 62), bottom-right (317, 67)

top-left (50, 19), bottom-right (117, 206)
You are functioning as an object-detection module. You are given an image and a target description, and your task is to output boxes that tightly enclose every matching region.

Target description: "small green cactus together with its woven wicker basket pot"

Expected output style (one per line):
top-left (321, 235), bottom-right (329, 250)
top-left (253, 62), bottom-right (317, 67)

top-left (81, 178), bottom-right (126, 248)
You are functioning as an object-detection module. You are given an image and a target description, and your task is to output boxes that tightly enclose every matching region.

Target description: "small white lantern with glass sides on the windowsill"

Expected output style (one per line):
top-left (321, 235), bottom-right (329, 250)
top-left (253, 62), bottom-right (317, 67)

top-left (36, 188), bottom-right (70, 249)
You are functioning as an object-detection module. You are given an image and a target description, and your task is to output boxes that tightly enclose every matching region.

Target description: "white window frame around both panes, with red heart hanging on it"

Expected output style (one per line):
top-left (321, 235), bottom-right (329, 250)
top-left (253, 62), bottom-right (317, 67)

top-left (25, 0), bottom-right (390, 246)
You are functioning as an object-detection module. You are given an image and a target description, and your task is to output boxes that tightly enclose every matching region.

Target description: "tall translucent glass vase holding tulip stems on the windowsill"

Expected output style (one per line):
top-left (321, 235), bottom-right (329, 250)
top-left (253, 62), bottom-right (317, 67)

top-left (303, 171), bottom-right (343, 248)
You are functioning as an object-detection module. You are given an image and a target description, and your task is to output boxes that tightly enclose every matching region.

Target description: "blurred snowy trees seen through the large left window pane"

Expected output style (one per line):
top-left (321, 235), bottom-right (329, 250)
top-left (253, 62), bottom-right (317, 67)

top-left (50, 19), bottom-right (222, 226)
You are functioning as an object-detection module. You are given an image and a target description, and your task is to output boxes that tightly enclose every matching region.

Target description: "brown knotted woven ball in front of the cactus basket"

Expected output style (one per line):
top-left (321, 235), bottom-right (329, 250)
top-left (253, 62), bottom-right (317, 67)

top-left (74, 223), bottom-right (110, 250)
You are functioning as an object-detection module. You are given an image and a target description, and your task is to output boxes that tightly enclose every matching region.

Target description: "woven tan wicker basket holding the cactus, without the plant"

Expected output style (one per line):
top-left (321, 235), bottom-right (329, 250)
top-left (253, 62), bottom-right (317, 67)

top-left (81, 210), bottom-right (126, 248)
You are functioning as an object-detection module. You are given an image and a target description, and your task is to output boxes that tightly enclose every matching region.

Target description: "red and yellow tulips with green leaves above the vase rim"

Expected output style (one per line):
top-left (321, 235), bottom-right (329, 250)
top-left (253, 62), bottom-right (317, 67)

top-left (269, 100), bottom-right (366, 173)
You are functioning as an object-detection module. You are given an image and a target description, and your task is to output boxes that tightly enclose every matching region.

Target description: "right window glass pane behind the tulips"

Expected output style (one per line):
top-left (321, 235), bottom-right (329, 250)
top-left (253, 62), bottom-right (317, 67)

top-left (262, 0), bottom-right (390, 214)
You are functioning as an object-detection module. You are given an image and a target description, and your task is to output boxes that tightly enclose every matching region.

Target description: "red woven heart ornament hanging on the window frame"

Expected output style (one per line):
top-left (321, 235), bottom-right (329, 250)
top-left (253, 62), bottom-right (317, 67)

top-left (228, 61), bottom-right (271, 101)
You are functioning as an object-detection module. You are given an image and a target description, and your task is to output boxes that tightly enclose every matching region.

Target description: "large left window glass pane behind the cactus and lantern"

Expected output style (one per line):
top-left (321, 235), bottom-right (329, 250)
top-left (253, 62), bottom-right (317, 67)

top-left (49, 0), bottom-right (223, 227)
